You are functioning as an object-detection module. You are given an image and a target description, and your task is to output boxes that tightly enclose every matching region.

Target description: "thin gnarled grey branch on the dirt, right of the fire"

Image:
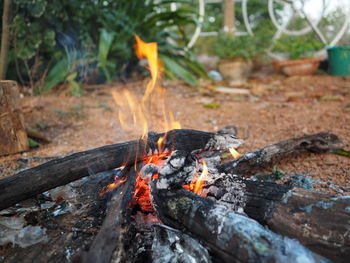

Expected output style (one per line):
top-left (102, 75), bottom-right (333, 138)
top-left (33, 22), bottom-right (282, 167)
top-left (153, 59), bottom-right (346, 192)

top-left (218, 132), bottom-right (342, 175)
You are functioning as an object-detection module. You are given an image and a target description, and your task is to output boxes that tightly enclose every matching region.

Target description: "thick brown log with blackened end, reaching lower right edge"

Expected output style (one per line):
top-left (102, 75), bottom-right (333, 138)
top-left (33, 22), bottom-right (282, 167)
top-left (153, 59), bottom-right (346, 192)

top-left (230, 180), bottom-right (350, 263)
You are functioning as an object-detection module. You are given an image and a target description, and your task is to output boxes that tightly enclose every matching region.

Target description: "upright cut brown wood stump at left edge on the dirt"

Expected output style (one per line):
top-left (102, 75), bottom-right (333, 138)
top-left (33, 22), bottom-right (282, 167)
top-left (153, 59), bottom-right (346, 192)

top-left (0, 80), bottom-right (29, 156)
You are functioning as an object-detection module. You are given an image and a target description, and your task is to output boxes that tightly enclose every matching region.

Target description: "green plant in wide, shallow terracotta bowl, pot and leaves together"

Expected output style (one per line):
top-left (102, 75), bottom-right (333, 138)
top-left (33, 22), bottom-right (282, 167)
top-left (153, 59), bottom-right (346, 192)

top-left (272, 36), bottom-right (323, 76)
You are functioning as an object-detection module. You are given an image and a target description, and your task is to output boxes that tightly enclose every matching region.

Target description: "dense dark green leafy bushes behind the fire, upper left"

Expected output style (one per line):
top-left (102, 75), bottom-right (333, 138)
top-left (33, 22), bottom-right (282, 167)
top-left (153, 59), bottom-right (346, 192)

top-left (0, 0), bottom-right (205, 92)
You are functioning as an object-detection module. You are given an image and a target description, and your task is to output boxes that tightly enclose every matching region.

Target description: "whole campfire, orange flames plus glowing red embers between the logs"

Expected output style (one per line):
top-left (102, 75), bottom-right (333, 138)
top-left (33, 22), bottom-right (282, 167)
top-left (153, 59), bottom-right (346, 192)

top-left (107, 35), bottom-right (186, 211)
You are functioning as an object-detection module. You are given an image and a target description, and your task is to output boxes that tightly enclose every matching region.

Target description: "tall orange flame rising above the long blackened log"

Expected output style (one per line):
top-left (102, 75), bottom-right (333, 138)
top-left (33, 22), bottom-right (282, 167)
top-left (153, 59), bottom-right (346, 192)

top-left (111, 35), bottom-right (181, 142)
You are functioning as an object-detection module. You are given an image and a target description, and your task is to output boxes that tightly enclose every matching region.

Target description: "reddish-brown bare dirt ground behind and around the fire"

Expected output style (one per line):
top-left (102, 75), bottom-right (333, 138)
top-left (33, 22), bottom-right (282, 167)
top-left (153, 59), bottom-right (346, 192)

top-left (0, 75), bottom-right (350, 194)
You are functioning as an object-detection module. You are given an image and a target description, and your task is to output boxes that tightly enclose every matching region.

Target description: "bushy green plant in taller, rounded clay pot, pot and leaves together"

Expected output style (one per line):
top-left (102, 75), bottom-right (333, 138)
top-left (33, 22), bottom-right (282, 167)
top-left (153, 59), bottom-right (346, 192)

top-left (213, 34), bottom-right (262, 85)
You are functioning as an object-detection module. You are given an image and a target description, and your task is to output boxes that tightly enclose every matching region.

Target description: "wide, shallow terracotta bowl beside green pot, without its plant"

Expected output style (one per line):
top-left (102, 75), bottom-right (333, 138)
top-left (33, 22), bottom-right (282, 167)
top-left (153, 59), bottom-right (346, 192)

top-left (272, 58), bottom-right (321, 76)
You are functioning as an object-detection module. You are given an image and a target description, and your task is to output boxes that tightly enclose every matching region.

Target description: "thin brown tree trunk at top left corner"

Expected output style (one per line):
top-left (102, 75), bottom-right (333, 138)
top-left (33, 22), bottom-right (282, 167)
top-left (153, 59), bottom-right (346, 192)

top-left (0, 0), bottom-right (12, 80)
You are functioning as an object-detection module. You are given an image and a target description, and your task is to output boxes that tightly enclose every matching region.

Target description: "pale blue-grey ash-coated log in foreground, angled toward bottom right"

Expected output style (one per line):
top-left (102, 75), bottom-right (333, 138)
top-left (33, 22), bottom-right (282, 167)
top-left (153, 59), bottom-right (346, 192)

top-left (151, 186), bottom-right (327, 263)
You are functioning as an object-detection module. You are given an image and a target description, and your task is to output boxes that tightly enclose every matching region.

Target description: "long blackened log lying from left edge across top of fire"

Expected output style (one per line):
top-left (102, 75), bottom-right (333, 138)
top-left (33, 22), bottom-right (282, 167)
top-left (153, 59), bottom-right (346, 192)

top-left (0, 129), bottom-right (239, 210)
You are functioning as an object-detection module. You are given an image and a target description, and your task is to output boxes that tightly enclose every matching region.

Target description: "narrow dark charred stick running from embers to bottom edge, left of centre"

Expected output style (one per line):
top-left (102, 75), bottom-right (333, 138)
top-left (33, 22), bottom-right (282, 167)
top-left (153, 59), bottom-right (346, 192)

top-left (82, 168), bottom-right (136, 263)
